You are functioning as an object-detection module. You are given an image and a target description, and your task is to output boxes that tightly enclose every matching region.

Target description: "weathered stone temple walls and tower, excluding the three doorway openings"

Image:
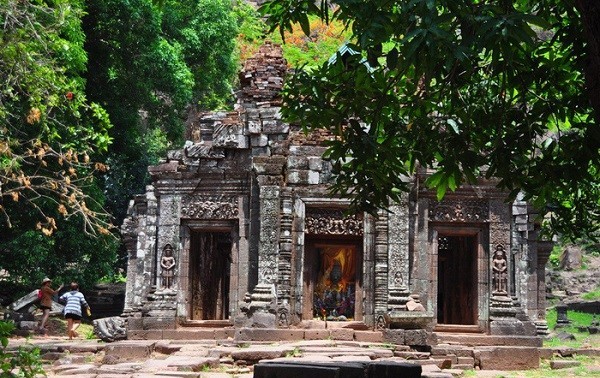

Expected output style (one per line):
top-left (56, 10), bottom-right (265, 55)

top-left (117, 43), bottom-right (543, 338)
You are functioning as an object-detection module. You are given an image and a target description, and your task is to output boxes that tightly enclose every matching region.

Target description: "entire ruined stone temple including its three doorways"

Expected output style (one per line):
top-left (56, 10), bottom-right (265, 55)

top-left (116, 44), bottom-right (550, 345)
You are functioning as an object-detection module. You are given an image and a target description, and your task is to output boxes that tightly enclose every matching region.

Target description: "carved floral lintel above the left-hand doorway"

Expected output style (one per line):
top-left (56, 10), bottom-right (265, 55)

top-left (181, 196), bottom-right (239, 219)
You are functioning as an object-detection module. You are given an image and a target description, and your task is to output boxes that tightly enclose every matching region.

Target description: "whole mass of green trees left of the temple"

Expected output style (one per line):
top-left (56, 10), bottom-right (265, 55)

top-left (0, 0), bottom-right (238, 296)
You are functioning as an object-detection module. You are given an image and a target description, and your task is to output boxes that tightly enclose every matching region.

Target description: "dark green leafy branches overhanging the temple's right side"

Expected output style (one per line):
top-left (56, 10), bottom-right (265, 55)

top-left (261, 0), bottom-right (600, 238)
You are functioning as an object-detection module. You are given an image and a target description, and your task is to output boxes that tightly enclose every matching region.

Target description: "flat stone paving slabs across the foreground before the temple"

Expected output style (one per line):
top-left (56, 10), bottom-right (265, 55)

top-left (4, 338), bottom-right (600, 378)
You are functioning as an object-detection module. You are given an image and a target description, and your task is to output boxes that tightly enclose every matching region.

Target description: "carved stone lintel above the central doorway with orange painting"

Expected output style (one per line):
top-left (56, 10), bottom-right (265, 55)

top-left (305, 209), bottom-right (363, 235)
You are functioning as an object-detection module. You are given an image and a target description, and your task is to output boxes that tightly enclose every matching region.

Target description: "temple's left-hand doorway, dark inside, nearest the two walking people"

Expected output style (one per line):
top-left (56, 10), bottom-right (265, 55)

top-left (190, 231), bottom-right (232, 320)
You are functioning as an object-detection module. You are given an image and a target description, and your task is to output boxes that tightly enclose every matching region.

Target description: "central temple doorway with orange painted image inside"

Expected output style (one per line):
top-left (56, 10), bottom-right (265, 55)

top-left (303, 240), bottom-right (363, 322)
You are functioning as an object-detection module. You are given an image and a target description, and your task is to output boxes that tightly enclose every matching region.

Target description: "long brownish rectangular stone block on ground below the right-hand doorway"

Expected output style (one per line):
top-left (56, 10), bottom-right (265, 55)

top-left (473, 346), bottom-right (540, 370)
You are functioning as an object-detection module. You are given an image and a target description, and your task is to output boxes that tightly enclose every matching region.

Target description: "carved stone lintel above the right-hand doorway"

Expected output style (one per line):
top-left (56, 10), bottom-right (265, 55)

top-left (429, 200), bottom-right (489, 222)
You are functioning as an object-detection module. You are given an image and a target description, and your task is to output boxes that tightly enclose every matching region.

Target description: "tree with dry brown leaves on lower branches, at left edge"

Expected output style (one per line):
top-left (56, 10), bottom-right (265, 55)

top-left (0, 0), bottom-right (110, 235)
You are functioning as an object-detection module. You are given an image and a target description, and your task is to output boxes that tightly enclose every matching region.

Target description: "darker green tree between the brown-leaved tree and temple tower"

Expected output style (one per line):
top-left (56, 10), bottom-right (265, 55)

top-left (84, 0), bottom-right (237, 223)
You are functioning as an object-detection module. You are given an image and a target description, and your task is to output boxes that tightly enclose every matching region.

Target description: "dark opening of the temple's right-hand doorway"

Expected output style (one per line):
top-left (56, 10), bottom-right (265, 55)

top-left (437, 235), bottom-right (478, 325)
